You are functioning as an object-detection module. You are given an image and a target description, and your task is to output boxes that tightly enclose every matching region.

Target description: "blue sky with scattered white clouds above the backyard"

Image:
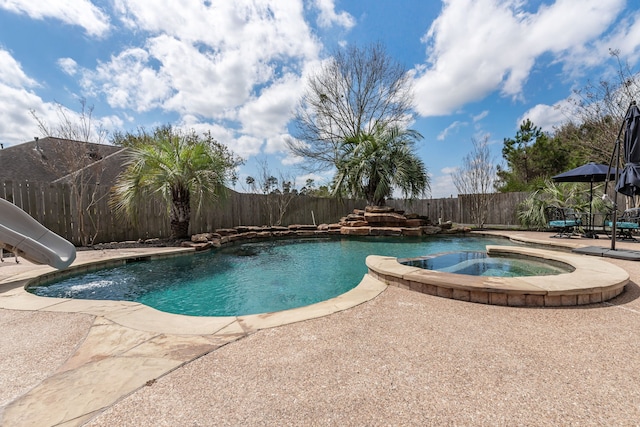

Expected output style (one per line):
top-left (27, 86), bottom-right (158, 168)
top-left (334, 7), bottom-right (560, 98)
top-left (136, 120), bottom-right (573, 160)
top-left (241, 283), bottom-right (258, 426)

top-left (0, 0), bottom-right (640, 198)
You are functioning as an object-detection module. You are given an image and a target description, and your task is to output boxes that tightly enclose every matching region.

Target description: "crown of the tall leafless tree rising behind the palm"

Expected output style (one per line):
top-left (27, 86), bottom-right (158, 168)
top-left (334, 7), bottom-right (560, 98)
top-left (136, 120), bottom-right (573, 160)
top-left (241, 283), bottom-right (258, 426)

top-left (288, 44), bottom-right (413, 170)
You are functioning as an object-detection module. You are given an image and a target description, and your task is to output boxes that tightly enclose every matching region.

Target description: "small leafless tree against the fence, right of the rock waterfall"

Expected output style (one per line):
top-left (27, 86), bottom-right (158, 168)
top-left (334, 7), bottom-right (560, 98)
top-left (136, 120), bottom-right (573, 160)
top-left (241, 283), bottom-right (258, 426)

top-left (452, 136), bottom-right (496, 228)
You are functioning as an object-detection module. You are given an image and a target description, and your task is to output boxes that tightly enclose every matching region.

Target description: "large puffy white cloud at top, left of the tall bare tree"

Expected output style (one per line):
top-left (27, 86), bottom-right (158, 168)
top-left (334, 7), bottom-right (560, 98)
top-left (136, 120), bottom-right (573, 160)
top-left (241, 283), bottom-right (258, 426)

top-left (83, 0), bottom-right (320, 140)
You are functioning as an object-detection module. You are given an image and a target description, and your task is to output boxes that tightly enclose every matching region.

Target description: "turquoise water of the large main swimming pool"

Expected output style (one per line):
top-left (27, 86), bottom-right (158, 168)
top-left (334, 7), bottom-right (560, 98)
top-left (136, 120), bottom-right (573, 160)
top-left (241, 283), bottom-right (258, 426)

top-left (27, 236), bottom-right (509, 316)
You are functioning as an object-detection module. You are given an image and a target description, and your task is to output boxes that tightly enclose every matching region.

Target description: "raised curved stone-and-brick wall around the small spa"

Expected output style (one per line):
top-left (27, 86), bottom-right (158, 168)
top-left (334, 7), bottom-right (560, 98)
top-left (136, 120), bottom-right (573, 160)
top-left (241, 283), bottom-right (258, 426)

top-left (366, 245), bottom-right (629, 307)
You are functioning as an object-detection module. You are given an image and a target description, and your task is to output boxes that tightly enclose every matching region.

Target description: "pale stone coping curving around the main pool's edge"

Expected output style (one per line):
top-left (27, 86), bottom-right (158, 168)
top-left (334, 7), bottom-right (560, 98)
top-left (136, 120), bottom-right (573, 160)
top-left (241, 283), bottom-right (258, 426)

top-left (0, 248), bottom-right (386, 335)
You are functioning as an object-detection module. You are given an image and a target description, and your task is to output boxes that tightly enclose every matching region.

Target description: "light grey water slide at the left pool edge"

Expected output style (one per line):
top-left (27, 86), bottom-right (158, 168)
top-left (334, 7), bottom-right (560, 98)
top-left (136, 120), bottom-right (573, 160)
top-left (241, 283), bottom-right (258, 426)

top-left (0, 199), bottom-right (76, 269)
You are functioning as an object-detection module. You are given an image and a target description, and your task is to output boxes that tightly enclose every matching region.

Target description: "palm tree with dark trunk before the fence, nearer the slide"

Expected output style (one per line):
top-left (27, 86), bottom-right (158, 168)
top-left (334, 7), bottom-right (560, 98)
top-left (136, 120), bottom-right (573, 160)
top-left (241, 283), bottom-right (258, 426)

top-left (111, 126), bottom-right (241, 238)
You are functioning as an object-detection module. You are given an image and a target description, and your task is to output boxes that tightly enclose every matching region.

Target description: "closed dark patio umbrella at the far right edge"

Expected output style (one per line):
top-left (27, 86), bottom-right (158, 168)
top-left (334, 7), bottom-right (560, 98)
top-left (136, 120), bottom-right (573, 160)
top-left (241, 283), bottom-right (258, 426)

top-left (616, 105), bottom-right (640, 196)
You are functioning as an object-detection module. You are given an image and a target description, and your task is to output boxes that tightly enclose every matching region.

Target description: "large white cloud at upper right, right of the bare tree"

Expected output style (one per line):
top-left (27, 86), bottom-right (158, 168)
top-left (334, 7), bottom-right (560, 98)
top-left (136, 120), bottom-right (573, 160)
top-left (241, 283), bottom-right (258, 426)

top-left (416, 0), bottom-right (625, 116)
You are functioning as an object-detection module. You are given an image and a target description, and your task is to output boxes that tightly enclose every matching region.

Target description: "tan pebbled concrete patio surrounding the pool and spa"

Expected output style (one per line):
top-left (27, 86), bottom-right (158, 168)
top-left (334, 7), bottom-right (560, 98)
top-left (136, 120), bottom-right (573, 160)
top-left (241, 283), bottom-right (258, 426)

top-left (0, 232), bottom-right (640, 426)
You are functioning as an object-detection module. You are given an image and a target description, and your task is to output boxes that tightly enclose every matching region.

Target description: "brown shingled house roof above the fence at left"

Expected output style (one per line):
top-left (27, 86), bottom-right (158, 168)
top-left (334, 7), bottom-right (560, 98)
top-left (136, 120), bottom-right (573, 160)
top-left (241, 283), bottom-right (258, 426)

top-left (0, 137), bottom-right (126, 186)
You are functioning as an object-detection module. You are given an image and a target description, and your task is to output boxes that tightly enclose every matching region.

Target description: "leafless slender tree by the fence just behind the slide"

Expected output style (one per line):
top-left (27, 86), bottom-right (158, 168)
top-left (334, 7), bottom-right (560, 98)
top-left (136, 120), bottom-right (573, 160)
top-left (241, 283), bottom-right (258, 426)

top-left (30, 99), bottom-right (108, 245)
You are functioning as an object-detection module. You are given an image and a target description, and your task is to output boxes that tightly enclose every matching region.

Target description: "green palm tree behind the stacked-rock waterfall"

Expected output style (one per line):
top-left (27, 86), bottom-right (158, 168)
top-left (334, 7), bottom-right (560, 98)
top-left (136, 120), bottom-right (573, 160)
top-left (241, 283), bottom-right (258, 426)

top-left (334, 126), bottom-right (429, 206)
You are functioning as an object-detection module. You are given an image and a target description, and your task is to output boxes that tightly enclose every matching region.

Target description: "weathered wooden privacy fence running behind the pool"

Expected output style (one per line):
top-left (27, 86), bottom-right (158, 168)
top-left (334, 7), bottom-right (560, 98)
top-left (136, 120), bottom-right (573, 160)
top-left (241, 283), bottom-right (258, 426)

top-left (0, 181), bottom-right (527, 246)
